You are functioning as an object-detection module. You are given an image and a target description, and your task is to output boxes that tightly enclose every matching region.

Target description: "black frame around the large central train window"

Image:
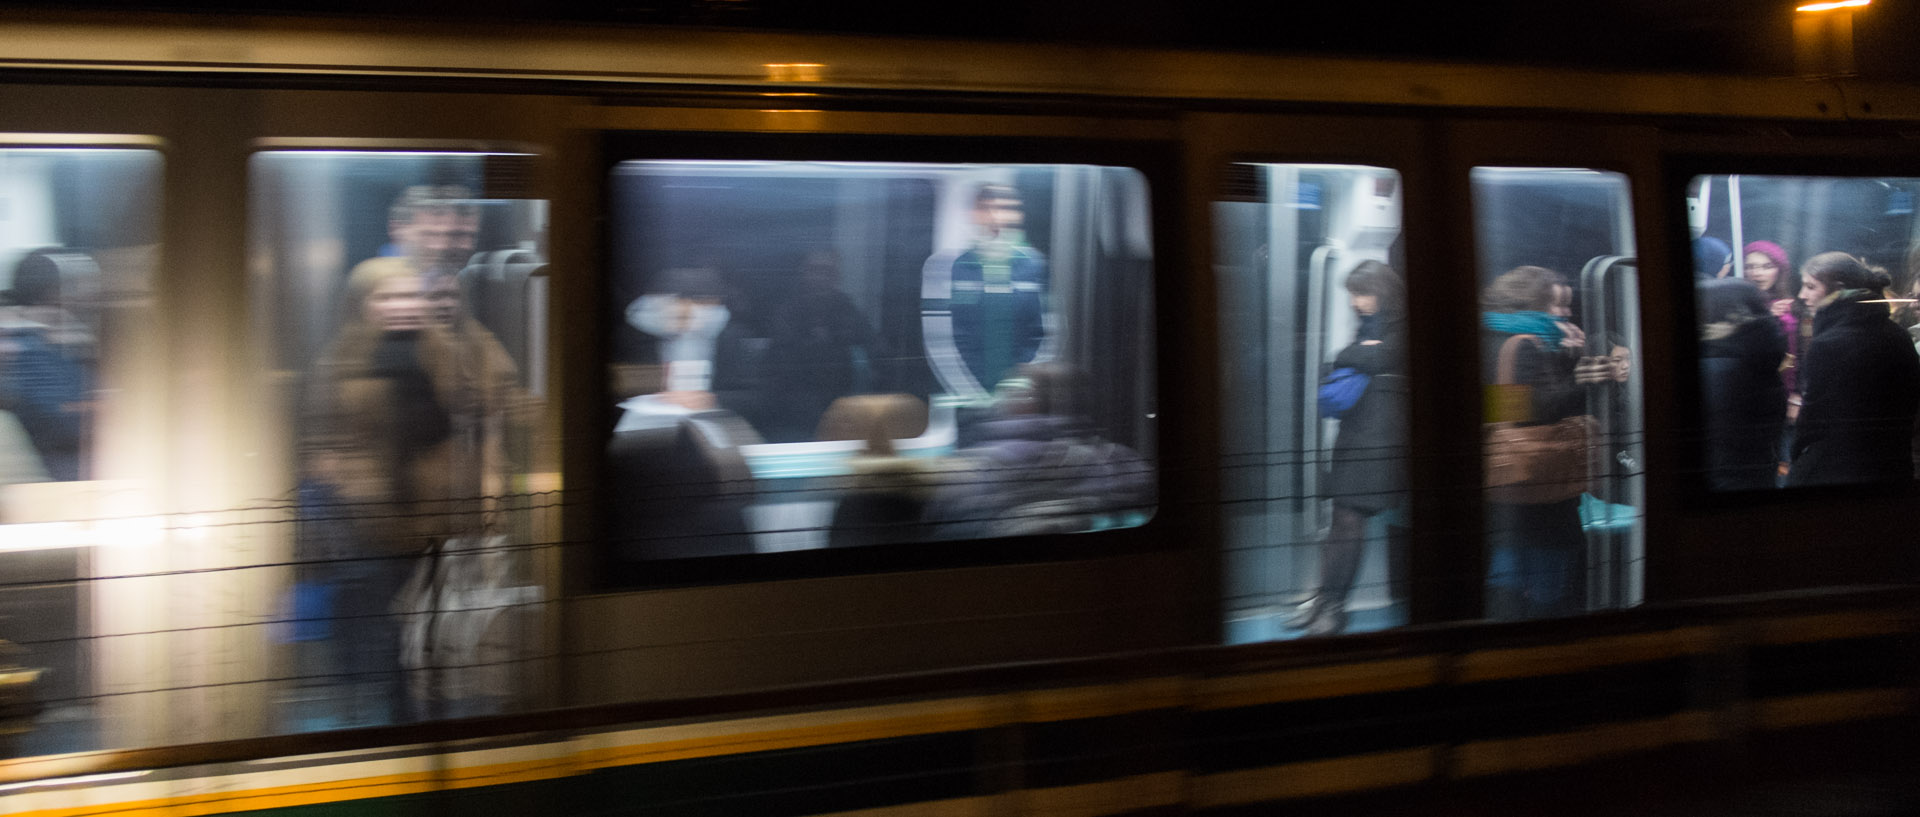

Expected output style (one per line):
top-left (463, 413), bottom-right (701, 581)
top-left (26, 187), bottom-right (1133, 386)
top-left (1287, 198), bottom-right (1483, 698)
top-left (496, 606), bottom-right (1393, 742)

top-left (587, 130), bottom-right (1182, 593)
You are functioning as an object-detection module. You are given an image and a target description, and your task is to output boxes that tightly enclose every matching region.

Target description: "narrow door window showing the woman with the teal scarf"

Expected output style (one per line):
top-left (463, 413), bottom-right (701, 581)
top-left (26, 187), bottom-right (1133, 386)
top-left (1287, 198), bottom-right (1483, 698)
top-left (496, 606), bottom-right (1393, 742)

top-left (1473, 167), bottom-right (1645, 619)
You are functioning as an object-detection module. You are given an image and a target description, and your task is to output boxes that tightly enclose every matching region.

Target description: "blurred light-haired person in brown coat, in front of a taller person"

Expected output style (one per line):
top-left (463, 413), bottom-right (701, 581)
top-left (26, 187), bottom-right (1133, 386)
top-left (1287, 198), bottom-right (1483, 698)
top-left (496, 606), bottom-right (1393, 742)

top-left (303, 259), bottom-right (511, 719)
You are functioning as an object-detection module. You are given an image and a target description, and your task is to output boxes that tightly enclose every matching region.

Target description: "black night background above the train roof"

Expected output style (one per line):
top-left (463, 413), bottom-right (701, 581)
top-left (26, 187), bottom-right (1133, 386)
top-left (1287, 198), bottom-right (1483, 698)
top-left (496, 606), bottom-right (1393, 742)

top-left (0, 0), bottom-right (1920, 79)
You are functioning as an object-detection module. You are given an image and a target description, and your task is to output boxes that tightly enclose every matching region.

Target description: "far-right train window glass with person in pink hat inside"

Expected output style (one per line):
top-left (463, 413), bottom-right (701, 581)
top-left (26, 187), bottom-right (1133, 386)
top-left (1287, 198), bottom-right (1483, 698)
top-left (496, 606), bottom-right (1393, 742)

top-left (1688, 175), bottom-right (1920, 491)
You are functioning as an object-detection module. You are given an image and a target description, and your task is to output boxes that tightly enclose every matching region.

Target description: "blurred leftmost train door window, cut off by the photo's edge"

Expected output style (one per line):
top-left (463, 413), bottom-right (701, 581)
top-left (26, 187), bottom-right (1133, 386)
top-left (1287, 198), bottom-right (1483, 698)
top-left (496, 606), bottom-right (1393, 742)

top-left (0, 138), bottom-right (161, 756)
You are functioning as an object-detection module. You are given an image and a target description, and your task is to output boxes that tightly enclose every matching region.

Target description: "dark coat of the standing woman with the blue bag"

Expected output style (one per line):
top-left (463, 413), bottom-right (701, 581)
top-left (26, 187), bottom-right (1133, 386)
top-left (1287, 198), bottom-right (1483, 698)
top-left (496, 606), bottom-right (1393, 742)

top-left (1321, 315), bottom-right (1407, 514)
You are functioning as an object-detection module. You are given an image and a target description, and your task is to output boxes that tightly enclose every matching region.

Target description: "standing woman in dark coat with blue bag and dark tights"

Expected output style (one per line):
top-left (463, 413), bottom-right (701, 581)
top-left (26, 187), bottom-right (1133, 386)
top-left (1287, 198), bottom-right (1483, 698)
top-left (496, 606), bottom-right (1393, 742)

top-left (1284, 261), bottom-right (1407, 635)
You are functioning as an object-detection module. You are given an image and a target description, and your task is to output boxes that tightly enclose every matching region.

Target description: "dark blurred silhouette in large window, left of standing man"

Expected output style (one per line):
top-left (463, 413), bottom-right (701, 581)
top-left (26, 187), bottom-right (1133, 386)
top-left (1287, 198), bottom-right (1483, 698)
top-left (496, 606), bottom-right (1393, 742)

top-left (764, 251), bottom-right (874, 443)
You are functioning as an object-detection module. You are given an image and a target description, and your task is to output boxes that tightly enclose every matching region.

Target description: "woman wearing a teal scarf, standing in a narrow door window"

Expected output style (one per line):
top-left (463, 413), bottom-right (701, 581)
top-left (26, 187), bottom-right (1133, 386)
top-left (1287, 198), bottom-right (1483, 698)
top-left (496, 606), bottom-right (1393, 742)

top-left (1480, 267), bottom-right (1607, 619)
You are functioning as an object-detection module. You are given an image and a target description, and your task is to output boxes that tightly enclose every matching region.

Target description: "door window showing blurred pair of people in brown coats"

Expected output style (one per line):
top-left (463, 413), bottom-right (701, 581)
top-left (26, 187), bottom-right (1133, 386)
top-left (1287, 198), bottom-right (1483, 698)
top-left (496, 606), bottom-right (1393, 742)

top-left (248, 150), bottom-right (551, 731)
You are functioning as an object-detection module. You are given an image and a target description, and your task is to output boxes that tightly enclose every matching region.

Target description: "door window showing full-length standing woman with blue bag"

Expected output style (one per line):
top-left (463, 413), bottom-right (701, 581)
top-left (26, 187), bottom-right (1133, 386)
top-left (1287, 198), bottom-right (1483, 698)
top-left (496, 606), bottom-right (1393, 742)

top-left (1213, 165), bottom-right (1407, 642)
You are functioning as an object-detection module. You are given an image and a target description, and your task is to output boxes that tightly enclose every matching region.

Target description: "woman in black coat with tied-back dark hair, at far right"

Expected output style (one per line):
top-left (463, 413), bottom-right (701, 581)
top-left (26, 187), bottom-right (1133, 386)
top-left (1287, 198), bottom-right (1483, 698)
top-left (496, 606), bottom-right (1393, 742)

top-left (1788, 253), bottom-right (1920, 485)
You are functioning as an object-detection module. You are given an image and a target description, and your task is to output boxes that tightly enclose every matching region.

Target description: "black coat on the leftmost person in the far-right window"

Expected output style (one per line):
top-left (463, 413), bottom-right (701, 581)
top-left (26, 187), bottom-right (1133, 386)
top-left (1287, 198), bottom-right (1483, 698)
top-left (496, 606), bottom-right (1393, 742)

top-left (1699, 316), bottom-right (1788, 491)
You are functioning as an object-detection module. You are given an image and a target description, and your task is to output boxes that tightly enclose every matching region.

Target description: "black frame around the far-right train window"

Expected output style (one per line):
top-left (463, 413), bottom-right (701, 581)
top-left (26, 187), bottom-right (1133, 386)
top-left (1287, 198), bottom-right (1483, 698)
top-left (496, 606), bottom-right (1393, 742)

top-left (1642, 154), bottom-right (1920, 512)
